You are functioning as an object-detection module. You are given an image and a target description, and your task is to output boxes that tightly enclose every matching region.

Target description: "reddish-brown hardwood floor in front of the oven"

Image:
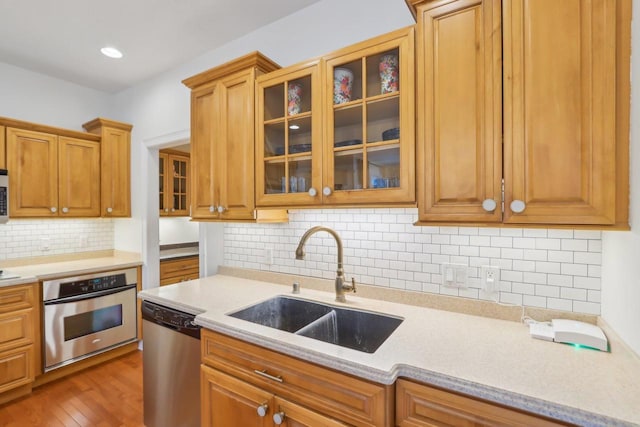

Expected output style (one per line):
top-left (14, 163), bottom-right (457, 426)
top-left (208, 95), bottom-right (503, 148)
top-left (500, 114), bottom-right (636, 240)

top-left (0, 351), bottom-right (144, 427)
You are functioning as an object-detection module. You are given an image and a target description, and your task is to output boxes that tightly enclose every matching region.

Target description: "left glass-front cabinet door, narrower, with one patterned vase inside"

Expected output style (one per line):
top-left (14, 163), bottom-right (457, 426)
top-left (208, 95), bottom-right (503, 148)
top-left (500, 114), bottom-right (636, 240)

top-left (256, 61), bottom-right (322, 206)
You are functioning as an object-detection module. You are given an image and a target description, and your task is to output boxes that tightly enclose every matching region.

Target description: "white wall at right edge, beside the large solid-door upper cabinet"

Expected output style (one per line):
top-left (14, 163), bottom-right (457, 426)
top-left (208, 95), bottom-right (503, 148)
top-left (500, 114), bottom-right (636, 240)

top-left (602, 5), bottom-right (640, 354)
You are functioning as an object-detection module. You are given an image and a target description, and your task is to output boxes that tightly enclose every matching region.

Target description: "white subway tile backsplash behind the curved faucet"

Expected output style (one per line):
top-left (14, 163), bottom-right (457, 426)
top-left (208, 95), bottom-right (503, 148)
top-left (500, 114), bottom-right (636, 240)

top-left (224, 208), bottom-right (602, 314)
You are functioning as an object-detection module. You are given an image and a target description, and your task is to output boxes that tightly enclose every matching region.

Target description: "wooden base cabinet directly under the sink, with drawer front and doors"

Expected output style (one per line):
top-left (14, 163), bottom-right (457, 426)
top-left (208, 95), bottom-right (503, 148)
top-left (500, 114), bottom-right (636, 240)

top-left (201, 329), bottom-right (394, 427)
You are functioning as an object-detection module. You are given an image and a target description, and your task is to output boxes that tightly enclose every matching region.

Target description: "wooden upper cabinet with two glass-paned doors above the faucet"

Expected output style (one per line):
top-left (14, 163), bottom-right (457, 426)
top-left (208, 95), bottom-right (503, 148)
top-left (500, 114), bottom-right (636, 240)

top-left (256, 27), bottom-right (415, 207)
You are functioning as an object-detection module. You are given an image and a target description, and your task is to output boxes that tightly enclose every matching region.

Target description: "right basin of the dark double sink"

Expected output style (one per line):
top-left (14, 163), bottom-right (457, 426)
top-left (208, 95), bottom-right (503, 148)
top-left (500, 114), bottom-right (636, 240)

top-left (296, 307), bottom-right (403, 353)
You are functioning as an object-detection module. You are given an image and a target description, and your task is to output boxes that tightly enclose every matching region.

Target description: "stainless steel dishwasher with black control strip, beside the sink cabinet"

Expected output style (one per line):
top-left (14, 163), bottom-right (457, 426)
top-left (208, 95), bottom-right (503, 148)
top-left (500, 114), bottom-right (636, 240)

top-left (142, 301), bottom-right (200, 427)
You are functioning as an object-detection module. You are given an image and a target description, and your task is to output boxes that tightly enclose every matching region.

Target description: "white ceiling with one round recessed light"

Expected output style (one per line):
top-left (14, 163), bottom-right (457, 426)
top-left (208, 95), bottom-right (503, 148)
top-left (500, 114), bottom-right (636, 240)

top-left (0, 0), bottom-right (320, 93)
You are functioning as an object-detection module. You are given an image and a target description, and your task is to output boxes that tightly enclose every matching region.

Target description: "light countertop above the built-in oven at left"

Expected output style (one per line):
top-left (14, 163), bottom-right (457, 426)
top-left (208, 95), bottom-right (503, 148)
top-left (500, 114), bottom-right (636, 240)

top-left (0, 251), bottom-right (142, 287)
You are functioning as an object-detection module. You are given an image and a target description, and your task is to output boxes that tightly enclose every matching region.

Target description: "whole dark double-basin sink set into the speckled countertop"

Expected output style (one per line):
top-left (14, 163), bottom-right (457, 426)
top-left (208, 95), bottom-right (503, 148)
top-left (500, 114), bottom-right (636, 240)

top-left (228, 295), bottom-right (404, 353)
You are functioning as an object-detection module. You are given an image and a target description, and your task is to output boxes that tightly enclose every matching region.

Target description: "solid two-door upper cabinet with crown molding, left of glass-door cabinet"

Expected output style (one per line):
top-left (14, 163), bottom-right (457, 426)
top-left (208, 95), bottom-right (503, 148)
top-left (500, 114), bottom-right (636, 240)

top-left (183, 52), bottom-right (279, 221)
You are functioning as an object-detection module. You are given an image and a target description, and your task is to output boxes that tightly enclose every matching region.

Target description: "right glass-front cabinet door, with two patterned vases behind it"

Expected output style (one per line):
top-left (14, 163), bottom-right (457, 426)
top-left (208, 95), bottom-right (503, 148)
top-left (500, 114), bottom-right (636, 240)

top-left (322, 27), bottom-right (415, 205)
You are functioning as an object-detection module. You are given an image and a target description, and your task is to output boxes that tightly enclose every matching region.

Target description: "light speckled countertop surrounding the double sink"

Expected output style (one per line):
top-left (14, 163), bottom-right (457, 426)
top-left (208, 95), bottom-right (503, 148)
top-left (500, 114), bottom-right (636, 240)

top-left (140, 275), bottom-right (640, 426)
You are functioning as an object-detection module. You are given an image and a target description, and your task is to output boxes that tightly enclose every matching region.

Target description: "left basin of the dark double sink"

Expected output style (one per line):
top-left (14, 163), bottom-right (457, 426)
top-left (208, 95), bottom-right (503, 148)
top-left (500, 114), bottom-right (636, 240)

top-left (229, 296), bottom-right (331, 332)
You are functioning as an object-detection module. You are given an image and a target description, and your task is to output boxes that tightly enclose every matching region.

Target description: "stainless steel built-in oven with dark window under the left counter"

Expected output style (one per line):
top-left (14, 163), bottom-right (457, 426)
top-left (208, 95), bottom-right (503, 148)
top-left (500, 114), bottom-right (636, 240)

top-left (42, 268), bottom-right (138, 372)
